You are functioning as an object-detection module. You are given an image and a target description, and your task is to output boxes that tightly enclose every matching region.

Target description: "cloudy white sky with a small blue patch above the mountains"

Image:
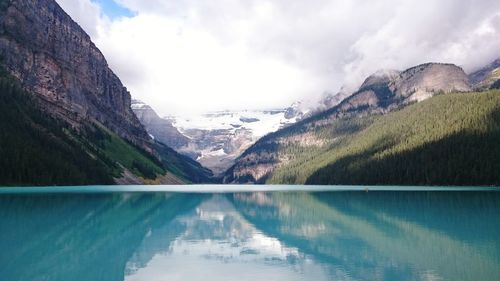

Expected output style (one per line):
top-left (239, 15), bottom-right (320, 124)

top-left (56, 0), bottom-right (500, 115)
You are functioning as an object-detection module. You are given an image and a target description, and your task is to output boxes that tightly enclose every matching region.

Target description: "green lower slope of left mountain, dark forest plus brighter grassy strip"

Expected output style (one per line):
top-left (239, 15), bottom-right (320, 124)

top-left (0, 67), bottom-right (212, 186)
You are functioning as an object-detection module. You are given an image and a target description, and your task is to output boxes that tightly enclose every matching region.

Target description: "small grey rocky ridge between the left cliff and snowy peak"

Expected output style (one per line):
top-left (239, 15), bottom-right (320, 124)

top-left (132, 100), bottom-right (189, 149)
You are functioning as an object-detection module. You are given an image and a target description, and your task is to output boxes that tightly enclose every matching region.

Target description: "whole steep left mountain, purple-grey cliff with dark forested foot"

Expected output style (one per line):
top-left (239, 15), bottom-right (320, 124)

top-left (0, 0), bottom-right (211, 185)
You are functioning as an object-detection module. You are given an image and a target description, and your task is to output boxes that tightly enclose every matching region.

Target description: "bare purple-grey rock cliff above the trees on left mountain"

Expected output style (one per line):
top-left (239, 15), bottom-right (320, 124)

top-left (0, 0), bottom-right (151, 148)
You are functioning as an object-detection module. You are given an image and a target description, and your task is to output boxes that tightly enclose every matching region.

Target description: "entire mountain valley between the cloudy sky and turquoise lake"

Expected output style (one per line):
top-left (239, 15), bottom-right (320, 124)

top-left (0, 0), bottom-right (500, 185)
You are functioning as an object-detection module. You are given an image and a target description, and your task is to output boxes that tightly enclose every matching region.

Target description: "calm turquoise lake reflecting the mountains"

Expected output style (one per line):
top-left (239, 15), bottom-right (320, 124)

top-left (0, 186), bottom-right (500, 281)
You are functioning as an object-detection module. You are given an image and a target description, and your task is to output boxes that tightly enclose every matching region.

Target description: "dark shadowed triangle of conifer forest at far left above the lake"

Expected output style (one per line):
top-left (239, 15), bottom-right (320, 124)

top-left (0, 66), bottom-right (113, 185)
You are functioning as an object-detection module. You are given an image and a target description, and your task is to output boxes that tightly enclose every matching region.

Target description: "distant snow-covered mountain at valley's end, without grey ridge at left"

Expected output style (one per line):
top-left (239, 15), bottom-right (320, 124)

top-left (170, 109), bottom-right (300, 174)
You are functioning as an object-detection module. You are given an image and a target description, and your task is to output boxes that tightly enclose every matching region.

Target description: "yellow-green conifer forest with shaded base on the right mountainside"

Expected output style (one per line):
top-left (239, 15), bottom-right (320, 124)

top-left (302, 90), bottom-right (500, 186)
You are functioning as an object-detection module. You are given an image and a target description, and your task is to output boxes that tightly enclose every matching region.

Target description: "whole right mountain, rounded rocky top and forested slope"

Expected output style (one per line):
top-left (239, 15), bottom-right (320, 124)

top-left (224, 64), bottom-right (500, 185)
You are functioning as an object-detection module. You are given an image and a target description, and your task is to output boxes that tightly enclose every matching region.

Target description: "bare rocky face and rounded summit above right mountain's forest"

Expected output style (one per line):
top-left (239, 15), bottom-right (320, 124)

top-left (225, 63), bottom-right (471, 183)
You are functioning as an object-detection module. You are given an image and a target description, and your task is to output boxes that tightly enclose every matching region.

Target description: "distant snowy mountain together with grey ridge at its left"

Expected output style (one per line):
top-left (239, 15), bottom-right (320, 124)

top-left (132, 101), bottom-right (298, 174)
